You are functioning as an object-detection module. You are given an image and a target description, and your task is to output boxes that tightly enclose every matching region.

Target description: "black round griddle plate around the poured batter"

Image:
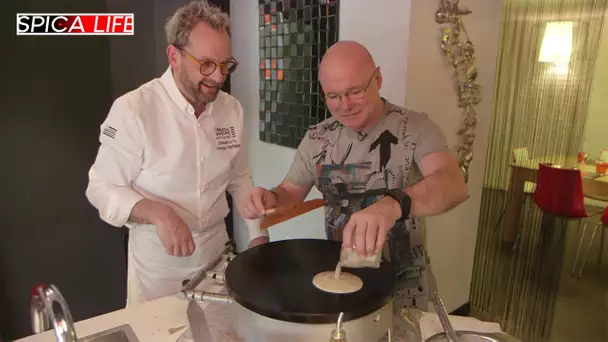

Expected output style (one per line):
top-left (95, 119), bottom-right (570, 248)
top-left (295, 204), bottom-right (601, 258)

top-left (225, 239), bottom-right (395, 323)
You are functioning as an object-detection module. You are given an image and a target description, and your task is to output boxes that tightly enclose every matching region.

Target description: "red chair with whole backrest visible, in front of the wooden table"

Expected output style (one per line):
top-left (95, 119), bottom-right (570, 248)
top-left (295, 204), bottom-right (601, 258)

top-left (534, 164), bottom-right (601, 278)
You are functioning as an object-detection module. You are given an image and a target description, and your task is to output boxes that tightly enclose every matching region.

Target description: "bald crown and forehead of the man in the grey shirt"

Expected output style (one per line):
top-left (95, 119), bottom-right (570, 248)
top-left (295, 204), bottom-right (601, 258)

top-left (319, 41), bottom-right (376, 82)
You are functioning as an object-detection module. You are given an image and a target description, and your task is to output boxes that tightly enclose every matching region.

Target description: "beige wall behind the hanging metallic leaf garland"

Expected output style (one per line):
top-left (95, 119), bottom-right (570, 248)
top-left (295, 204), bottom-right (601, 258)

top-left (406, 0), bottom-right (502, 310)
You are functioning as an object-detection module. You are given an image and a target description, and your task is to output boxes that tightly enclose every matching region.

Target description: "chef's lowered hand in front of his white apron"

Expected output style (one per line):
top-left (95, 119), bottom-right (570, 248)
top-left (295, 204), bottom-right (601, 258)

top-left (151, 203), bottom-right (195, 257)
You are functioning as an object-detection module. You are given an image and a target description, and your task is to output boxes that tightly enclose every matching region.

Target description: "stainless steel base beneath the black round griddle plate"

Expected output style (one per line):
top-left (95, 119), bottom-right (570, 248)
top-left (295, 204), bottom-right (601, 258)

top-left (230, 300), bottom-right (393, 342)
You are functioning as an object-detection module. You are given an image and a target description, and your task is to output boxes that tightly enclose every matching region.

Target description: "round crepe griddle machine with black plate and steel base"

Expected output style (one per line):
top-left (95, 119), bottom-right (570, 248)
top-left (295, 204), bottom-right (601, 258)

top-left (180, 239), bottom-right (395, 342)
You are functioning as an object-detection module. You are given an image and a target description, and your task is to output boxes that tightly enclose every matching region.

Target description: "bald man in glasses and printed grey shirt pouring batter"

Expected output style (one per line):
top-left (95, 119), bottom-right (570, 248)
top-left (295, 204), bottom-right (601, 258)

top-left (244, 42), bottom-right (467, 310)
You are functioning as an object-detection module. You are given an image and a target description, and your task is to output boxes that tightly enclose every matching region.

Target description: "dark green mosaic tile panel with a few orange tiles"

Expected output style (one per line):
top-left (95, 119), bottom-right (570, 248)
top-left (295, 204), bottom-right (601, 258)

top-left (259, 0), bottom-right (339, 148)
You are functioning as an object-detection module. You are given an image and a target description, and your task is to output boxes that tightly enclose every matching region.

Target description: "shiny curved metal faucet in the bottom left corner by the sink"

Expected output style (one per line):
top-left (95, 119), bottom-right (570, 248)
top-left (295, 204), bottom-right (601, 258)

top-left (30, 284), bottom-right (78, 342)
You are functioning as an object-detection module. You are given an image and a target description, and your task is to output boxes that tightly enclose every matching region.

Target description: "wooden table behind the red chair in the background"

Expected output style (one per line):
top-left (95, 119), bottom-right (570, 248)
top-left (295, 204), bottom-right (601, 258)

top-left (502, 157), bottom-right (608, 243)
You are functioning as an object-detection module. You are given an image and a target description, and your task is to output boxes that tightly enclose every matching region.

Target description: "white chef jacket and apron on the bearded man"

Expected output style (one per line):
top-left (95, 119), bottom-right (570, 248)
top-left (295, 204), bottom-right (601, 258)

top-left (86, 68), bottom-right (265, 305)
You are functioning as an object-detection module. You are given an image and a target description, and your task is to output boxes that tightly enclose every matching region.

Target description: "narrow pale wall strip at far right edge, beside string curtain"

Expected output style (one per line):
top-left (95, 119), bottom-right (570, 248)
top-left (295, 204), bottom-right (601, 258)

top-left (583, 24), bottom-right (608, 159)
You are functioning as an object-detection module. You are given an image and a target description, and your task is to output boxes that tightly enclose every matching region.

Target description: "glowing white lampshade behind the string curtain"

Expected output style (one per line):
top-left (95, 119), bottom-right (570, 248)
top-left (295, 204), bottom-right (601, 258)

top-left (538, 21), bottom-right (572, 65)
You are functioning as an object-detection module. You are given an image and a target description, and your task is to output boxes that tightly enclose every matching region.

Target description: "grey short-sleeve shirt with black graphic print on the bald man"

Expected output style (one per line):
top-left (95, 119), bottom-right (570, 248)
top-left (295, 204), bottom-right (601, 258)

top-left (286, 100), bottom-right (448, 309)
